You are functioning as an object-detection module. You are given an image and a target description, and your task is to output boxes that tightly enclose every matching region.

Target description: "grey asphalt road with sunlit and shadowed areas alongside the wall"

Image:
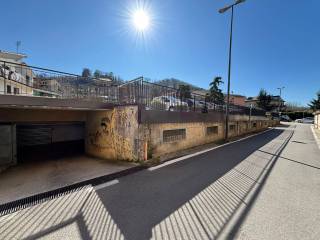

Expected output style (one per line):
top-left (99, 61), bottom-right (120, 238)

top-left (0, 124), bottom-right (320, 240)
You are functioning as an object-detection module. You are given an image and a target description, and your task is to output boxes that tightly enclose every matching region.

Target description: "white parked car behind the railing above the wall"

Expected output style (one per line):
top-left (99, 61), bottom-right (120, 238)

top-left (151, 96), bottom-right (189, 111)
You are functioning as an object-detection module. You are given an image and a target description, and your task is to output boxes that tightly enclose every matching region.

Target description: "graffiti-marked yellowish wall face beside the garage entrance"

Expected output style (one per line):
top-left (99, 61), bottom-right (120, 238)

top-left (86, 106), bottom-right (139, 161)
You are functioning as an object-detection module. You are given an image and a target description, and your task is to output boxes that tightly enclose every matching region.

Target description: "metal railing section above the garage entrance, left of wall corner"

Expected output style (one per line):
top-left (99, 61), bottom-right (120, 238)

top-left (0, 61), bottom-right (119, 103)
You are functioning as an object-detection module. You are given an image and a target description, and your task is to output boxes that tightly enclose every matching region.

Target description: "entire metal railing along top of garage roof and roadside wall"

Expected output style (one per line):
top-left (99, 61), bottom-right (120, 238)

top-left (0, 61), bottom-right (265, 116)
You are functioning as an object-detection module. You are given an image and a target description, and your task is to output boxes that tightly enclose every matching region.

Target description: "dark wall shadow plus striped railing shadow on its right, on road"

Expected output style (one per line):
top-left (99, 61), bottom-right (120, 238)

top-left (97, 129), bottom-right (292, 240)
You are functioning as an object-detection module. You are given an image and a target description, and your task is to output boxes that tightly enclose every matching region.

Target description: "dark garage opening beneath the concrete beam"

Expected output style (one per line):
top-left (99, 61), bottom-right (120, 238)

top-left (16, 122), bottom-right (85, 163)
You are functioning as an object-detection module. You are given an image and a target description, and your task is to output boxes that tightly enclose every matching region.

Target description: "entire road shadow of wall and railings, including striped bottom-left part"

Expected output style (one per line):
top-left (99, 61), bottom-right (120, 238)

top-left (0, 126), bottom-right (293, 240)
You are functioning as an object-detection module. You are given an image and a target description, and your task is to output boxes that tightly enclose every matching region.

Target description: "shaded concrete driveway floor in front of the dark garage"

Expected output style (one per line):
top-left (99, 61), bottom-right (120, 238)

top-left (0, 156), bottom-right (136, 205)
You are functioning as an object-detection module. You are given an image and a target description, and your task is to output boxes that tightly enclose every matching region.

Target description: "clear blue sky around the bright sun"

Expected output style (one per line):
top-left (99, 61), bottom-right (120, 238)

top-left (0, 0), bottom-right (320, 105)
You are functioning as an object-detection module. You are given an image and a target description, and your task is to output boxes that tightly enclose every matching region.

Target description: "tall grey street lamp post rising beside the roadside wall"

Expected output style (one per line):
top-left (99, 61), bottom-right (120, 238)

top-left (219, 0), bottom-right (245, 140)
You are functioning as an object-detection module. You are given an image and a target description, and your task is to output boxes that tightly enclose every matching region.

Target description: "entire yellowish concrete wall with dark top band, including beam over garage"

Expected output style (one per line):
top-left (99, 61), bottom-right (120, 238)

top-left (0, 103), bottom-right (276, 161)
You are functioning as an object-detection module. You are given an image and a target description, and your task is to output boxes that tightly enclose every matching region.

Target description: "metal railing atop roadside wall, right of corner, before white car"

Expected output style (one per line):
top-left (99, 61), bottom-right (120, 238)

top-left (119, 77), bottom-right (266, 116)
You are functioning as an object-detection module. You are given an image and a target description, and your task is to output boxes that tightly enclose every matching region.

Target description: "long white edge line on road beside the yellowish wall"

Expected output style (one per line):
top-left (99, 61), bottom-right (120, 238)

top-left (148, 128), bottom-right (274, 171)
